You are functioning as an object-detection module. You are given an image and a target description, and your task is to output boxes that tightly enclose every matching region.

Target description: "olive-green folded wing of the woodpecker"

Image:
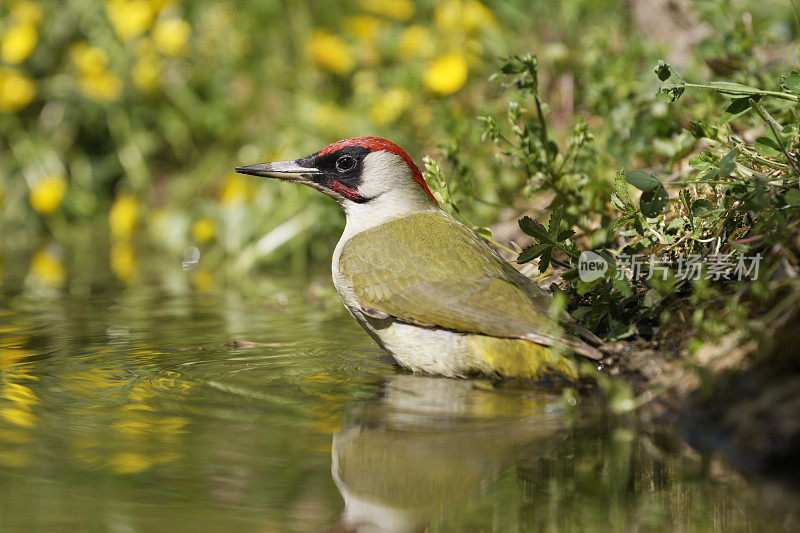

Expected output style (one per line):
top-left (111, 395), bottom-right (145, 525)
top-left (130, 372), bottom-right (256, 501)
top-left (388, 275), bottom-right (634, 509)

top-left (339, 212), bottom-right (553, 344)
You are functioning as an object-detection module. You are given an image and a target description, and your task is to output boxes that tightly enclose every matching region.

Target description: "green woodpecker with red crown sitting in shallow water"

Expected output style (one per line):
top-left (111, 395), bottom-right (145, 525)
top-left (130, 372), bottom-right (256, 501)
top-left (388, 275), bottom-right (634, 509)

top-left (236, 137), bottom-right (601, 378)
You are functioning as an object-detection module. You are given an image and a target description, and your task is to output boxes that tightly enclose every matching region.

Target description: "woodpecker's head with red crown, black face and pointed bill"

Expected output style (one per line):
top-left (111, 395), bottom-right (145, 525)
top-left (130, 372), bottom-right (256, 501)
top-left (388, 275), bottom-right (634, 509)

top-left (236, 137), bottom-right (436, 211)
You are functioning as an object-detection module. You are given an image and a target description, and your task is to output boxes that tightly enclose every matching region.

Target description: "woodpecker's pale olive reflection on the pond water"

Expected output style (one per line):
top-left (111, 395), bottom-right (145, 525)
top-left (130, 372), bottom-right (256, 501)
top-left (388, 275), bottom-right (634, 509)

top-left (331, 375), bottom-right (565, 531)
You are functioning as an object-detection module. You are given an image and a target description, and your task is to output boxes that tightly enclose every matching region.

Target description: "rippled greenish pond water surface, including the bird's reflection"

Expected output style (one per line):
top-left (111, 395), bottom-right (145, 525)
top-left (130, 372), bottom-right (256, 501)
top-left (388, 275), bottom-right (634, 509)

top-left (0, 276), bottom-right (798, 532)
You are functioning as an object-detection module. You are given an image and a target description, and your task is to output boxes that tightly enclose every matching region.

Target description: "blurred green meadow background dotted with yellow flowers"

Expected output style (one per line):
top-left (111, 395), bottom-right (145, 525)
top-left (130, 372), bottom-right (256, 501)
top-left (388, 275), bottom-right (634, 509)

top-left (0, 0), bottom-right (796, 293)
